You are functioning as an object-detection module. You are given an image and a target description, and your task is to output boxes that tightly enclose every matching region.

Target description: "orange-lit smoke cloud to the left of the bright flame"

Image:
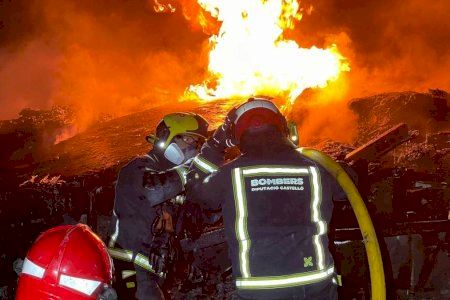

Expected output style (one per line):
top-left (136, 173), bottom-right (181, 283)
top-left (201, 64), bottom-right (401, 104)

top-left (0, 0), bottom-right (207, 129)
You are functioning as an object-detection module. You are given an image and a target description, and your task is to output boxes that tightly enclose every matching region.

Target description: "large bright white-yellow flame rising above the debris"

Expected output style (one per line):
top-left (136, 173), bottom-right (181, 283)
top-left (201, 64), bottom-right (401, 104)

top-left (185, 0), bottom-right (349, 103)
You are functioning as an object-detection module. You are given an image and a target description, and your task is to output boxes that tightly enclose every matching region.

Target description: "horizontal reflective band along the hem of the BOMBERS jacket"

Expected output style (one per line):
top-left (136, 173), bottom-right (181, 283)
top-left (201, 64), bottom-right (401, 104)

top-left (236, 267), bottom-right (334, 289)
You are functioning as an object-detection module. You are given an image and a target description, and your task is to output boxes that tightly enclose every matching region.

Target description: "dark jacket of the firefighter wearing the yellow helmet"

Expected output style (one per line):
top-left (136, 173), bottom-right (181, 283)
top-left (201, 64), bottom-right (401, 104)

top-left (108, 152), bottom-right (187, 280)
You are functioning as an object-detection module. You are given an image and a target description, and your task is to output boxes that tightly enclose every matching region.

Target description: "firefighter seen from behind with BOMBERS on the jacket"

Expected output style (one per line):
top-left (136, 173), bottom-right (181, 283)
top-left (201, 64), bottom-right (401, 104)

top-left (186, 98), bottom-right (337, 299)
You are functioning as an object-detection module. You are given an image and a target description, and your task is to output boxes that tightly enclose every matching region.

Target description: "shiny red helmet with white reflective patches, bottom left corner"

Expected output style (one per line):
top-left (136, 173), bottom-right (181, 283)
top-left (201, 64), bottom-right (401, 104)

top-left (16, 224), bottom-right (113, 300)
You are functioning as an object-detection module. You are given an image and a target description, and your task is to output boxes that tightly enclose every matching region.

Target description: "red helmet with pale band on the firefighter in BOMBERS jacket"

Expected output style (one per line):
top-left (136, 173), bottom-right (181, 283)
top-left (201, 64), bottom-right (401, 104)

top-left (233, 98), bottom-right (287, 141)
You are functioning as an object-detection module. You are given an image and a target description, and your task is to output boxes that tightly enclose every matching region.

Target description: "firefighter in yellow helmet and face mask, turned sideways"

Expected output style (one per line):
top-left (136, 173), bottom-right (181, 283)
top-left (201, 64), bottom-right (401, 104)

top-left (108, 113), bottom-right (208, 300)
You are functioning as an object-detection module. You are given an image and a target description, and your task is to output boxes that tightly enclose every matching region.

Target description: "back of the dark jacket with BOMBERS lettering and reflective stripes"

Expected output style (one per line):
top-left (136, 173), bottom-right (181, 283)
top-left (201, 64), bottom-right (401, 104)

top-left (223, 138), bottom-right (335, 299)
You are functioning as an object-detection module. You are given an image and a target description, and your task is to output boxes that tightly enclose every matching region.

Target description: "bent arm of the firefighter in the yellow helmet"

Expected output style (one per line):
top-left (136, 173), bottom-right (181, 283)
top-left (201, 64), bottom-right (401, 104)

top-left (142, 165), bottom-right (188, 206)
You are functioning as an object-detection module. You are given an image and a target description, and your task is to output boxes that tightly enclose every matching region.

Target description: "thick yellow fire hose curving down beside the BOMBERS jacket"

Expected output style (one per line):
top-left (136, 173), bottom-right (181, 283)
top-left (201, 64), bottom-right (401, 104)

top-left (300, 148), bottom-right (386, 300)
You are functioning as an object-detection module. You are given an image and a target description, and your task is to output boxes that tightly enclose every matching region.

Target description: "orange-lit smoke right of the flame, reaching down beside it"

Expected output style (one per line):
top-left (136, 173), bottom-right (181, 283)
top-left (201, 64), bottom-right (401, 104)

top-left (287, 0), bottom-right (450, 145)
